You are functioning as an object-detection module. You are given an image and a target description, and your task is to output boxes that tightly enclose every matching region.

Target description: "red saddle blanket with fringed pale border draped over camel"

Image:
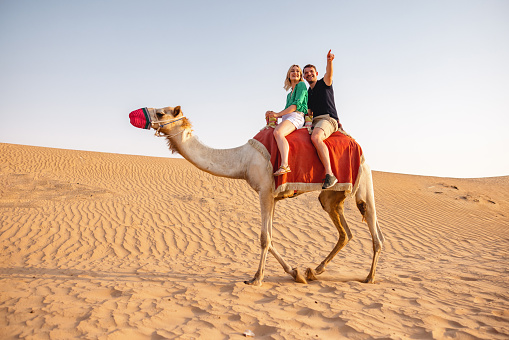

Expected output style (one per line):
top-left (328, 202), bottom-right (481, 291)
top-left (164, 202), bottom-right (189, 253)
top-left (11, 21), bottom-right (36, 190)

top-left (251, 128), bottom-right (364, 195)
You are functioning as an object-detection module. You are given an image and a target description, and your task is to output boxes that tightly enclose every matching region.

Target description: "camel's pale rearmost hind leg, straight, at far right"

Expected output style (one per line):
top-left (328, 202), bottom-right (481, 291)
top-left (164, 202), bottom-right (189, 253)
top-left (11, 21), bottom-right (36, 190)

top-left (355, 165), bottom-right (385, 283)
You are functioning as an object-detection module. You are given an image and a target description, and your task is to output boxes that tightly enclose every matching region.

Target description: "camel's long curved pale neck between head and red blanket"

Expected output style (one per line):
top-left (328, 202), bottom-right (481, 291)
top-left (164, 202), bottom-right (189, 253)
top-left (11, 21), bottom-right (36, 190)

top-left (168, 130), bottom-right (246, 179)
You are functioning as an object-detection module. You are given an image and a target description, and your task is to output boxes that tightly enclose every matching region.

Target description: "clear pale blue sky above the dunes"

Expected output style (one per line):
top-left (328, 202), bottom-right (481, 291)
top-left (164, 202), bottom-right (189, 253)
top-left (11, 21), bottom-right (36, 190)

top-left (0, 0), bottom-right (509, 177)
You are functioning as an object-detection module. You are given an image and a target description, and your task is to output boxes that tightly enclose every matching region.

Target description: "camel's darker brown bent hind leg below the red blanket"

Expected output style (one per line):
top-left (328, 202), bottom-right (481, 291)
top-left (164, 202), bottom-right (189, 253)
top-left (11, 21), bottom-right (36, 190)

top-left (306, 191), bottom-right (352, 280)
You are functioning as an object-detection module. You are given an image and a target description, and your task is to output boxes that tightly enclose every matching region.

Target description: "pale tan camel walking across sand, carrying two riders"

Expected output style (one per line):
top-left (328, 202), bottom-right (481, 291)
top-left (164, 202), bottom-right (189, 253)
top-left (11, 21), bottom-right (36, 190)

top-left (133, 106), bottom-right (385, 286)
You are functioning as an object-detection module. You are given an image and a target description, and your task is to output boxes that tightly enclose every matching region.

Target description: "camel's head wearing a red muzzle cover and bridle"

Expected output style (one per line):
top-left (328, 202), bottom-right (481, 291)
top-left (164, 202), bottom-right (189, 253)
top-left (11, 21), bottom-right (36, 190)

top-left (129, 106), bottom-right (191, 134)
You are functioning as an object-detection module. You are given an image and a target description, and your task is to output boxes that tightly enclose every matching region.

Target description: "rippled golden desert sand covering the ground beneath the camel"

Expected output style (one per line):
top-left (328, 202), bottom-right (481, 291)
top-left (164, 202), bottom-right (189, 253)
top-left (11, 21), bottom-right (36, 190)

top-left (0, 144), bottom-right (509, 340)
